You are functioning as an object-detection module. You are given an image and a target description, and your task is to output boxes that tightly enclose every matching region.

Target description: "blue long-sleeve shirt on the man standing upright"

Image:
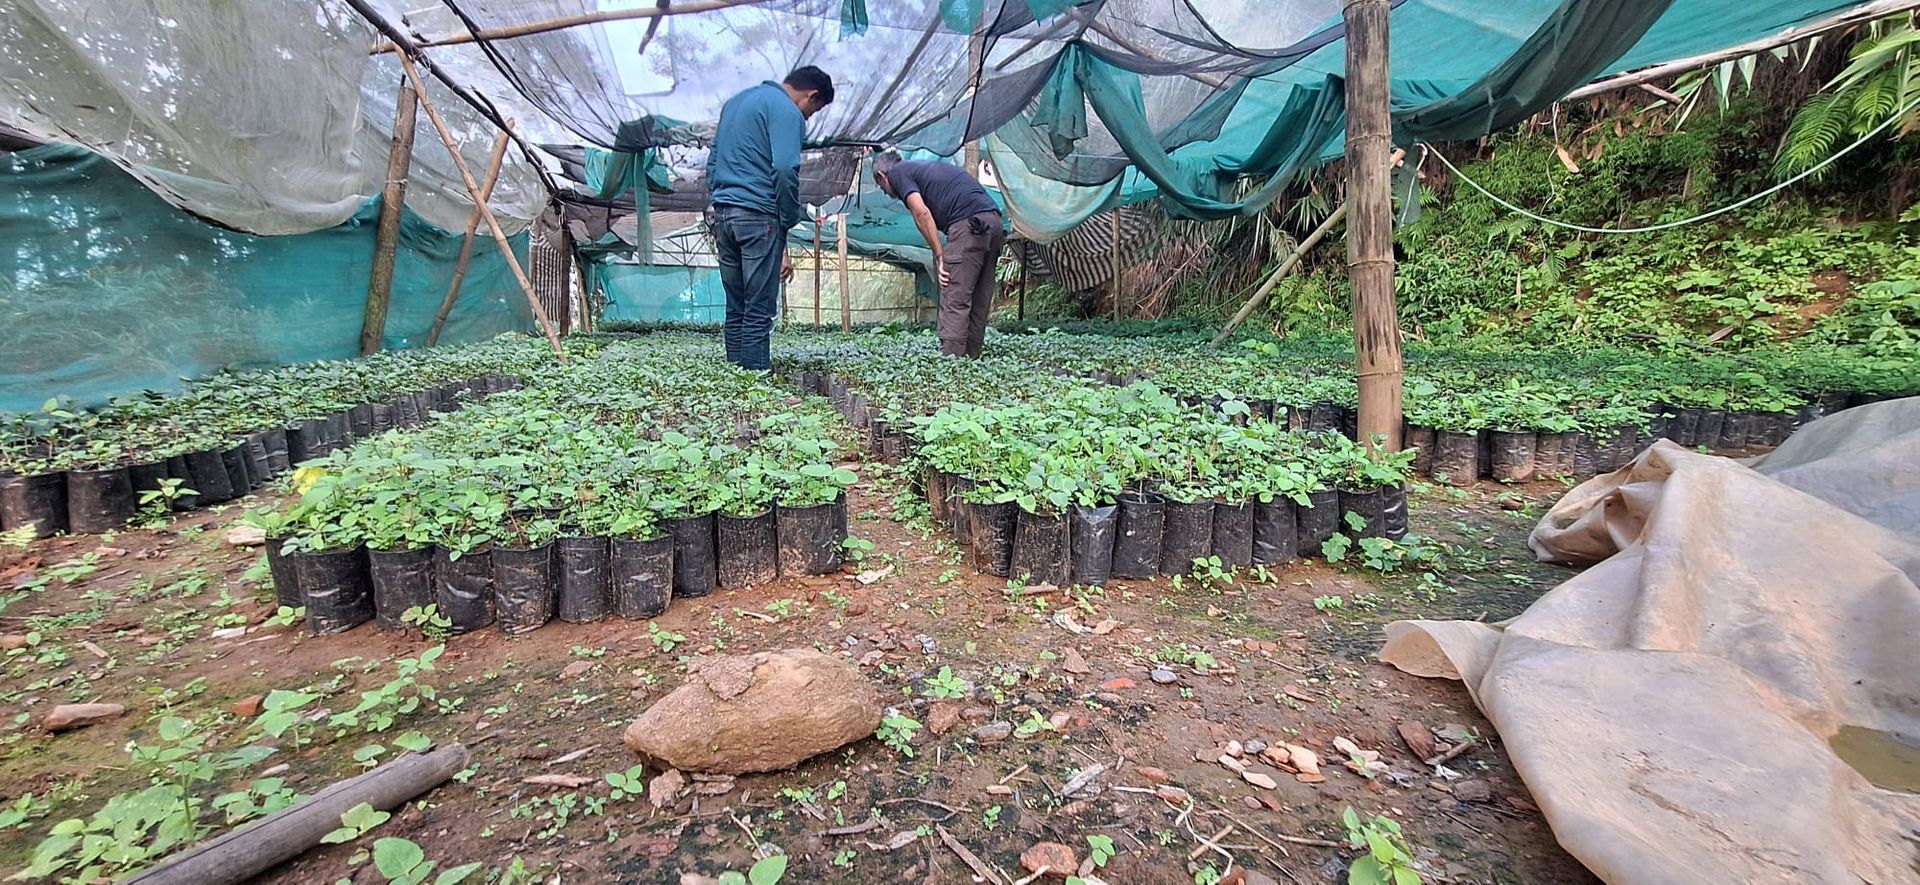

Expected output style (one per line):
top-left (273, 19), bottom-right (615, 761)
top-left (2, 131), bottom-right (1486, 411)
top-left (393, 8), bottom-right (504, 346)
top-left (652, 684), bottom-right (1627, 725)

top-left (707, 81), bottom-right (806, 230)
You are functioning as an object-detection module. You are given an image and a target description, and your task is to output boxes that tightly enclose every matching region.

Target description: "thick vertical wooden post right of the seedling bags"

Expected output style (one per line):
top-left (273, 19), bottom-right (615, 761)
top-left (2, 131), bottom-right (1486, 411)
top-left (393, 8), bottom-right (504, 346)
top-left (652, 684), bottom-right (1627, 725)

top-left (1342, 0), bottom-right (1402, 451)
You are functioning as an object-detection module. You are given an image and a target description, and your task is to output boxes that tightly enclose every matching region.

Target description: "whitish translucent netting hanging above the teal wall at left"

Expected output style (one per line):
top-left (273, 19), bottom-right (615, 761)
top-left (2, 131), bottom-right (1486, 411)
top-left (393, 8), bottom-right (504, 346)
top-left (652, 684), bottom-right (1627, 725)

top-left (0, 0), bottom-right (545, 234)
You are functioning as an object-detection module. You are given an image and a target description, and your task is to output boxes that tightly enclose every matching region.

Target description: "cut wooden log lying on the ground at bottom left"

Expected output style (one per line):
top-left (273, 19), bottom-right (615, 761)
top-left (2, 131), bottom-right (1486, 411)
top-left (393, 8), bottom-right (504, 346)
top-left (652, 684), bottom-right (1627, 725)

top-left (127, 743), bottom-right (468, 885)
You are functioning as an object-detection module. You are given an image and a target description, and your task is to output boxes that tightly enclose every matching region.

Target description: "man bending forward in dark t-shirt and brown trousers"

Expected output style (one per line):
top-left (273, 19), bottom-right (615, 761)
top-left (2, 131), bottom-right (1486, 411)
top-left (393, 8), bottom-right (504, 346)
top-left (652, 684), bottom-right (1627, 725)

top-left (874, 152), bottom-right (1006, 357)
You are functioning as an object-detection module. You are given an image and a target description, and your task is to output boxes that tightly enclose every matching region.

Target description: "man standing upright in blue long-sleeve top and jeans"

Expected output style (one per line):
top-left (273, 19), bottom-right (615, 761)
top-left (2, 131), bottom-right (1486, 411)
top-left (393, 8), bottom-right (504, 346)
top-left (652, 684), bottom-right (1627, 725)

top-left (707, 65), bottom-right (833, 369)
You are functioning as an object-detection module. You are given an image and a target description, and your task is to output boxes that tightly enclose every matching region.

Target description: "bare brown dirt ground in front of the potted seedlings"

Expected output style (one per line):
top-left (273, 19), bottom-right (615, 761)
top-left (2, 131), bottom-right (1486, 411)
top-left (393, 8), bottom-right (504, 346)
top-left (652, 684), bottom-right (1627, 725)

top-left (0, 465), bottom-right (1592, 883)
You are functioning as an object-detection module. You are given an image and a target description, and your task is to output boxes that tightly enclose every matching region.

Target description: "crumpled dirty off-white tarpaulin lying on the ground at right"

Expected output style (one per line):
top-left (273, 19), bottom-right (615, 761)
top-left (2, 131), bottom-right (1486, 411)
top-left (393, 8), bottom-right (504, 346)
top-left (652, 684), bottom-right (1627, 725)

top-left (1380, 399), bottom-right (1920, 885)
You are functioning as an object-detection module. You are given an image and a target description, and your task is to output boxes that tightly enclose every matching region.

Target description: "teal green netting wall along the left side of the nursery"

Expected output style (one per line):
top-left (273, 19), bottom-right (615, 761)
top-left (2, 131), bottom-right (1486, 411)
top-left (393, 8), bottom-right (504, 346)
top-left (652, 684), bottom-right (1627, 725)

top-left (0, 146), bottom-right (534, 411)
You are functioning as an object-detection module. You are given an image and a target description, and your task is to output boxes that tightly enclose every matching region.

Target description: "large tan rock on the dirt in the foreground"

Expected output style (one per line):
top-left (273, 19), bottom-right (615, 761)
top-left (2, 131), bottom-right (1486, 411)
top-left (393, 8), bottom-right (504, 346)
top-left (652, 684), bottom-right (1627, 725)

top-left (626, 649), bottom-right (881, 774)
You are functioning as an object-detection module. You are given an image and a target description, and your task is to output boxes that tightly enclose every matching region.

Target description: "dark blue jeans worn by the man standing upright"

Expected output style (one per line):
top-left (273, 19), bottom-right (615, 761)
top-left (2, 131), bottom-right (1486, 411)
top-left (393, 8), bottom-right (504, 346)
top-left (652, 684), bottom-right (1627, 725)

top-left (714, 205), bottom-right (787, 371)
